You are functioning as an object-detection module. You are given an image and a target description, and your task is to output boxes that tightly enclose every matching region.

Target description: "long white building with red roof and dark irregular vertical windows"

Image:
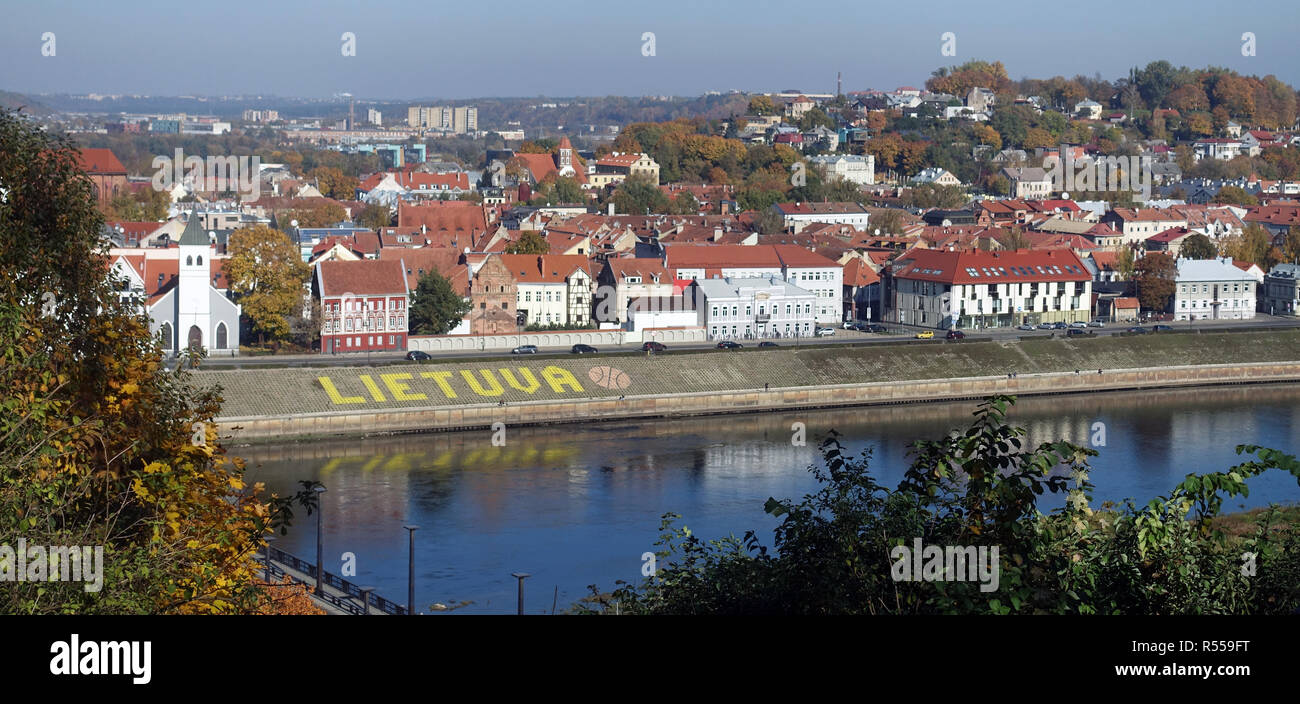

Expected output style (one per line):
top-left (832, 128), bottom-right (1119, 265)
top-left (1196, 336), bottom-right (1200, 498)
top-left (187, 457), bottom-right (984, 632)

top-left (881, 249), bottom-right (1092, 329)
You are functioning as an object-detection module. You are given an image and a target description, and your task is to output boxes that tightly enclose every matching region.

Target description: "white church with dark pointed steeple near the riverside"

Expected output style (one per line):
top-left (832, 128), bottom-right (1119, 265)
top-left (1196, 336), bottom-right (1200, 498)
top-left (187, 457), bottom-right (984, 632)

top-left (113, 214), bottom-right (239, 355)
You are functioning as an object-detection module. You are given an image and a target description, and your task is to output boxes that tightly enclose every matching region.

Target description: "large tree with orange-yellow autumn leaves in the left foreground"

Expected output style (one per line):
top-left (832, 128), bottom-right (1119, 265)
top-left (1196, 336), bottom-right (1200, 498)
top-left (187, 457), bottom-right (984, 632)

top-left (0, 110), bottom-right (295, 614)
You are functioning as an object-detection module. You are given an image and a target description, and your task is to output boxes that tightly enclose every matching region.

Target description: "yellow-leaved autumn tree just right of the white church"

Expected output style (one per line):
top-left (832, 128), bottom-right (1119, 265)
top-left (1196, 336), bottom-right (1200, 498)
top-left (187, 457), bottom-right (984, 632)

top-left (225, 225), bottom-right (311, 343)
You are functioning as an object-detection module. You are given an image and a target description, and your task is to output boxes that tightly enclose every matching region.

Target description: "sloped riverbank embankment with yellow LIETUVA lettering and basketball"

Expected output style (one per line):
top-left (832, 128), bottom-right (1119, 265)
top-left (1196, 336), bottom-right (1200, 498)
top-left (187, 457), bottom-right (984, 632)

top-left (196, 331), bottom-right (1300, 443)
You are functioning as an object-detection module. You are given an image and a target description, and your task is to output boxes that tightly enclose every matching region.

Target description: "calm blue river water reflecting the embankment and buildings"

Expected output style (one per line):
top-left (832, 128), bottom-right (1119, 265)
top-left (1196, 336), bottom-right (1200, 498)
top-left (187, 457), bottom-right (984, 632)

top-left (233, 384), bottom-right (1300, 613)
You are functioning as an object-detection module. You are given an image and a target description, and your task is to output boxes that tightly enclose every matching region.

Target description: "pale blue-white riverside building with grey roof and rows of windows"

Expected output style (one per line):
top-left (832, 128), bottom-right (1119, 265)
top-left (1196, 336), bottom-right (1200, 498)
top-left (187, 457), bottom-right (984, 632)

top-left (692, 277), bottom-right (818, 339)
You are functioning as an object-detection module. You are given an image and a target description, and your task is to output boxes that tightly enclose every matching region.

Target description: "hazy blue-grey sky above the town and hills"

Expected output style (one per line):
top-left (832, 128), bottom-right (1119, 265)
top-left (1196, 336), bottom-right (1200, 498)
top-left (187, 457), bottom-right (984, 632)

top-left (0, 0), bottom-right (1300, 99)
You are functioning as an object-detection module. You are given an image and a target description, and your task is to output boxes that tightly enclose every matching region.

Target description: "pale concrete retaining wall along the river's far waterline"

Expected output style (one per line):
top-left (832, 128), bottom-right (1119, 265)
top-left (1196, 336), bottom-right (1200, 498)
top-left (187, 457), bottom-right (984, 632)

top-left (217, 362), bottom-right (1300, 443)
